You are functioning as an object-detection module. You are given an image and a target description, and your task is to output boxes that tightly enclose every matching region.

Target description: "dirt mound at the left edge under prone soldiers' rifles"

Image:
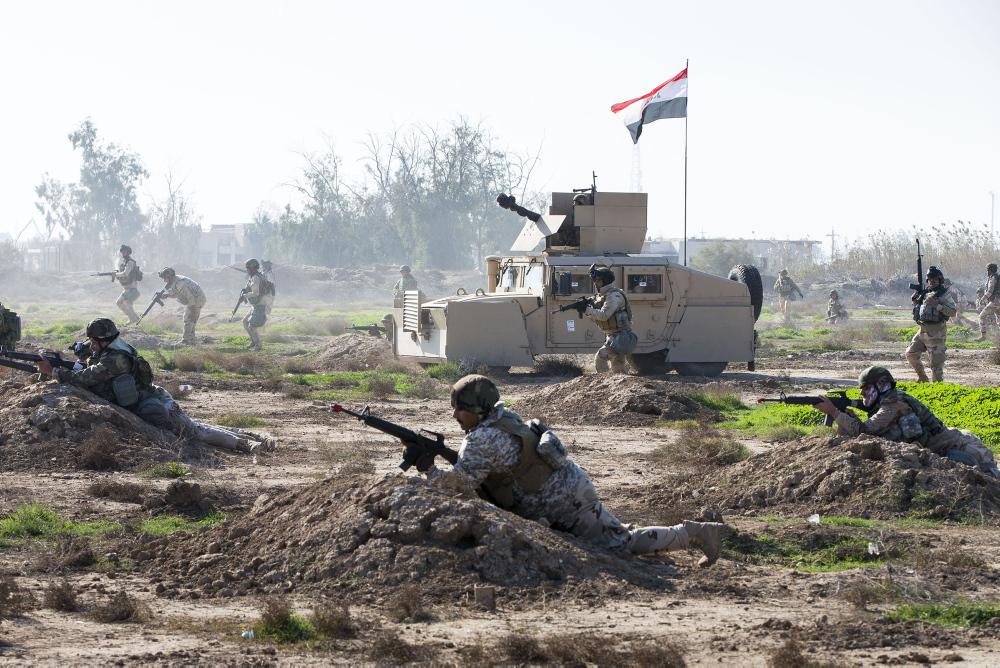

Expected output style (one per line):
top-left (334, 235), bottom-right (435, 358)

top-left (0, 379), bottom-right (211, 471)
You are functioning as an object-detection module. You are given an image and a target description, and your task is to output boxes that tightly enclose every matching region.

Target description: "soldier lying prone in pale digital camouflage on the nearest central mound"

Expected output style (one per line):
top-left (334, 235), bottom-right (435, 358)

top-left (417, 375), bottom-right (730, 567)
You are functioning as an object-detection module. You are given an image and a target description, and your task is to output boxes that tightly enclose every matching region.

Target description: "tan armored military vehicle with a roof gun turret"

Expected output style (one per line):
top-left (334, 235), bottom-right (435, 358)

top-left (386, 187), bottom-right (763, 376)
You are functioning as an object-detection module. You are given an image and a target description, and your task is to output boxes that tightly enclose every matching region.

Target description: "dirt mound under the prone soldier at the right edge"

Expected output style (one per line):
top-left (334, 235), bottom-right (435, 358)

top-left (646, 436), bottom-right (1000, 524)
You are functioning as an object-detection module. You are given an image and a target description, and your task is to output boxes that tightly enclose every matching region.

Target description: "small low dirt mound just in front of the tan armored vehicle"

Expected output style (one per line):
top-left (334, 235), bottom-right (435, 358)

top-left (515, 374), bottom-right (719, 427)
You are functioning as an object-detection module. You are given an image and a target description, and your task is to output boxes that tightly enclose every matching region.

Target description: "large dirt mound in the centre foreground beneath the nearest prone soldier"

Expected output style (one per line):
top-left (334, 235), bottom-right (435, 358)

top-left (133, 474), bottom-right (675, 602)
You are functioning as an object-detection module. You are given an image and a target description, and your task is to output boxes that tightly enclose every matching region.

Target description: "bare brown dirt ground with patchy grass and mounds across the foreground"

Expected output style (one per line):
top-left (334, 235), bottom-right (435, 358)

top-left (0, 298), bottom-right (1000, 666)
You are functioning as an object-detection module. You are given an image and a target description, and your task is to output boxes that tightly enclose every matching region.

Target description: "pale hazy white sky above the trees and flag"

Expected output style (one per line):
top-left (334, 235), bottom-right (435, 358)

top-left (0, 0), bottom-right (1000, 254)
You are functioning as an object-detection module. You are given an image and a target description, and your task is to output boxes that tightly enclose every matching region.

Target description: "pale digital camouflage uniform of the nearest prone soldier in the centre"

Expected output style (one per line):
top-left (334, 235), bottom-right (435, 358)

top-left (427, 402), bottom-right (724, 554)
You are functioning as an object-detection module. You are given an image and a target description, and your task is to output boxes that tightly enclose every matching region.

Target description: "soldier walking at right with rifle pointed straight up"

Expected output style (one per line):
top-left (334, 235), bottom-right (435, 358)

top-left (906, 267), bottom-right (955, 383)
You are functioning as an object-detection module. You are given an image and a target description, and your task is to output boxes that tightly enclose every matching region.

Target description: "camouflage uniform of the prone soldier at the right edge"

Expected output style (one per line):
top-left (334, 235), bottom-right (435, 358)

top-left (834, 389), bottom-right (1000, 477)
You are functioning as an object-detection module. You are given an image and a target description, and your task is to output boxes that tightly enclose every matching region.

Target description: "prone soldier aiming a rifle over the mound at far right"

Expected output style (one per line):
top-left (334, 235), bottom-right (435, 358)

top-left (814, 366), bottom-right (1000, 478)
